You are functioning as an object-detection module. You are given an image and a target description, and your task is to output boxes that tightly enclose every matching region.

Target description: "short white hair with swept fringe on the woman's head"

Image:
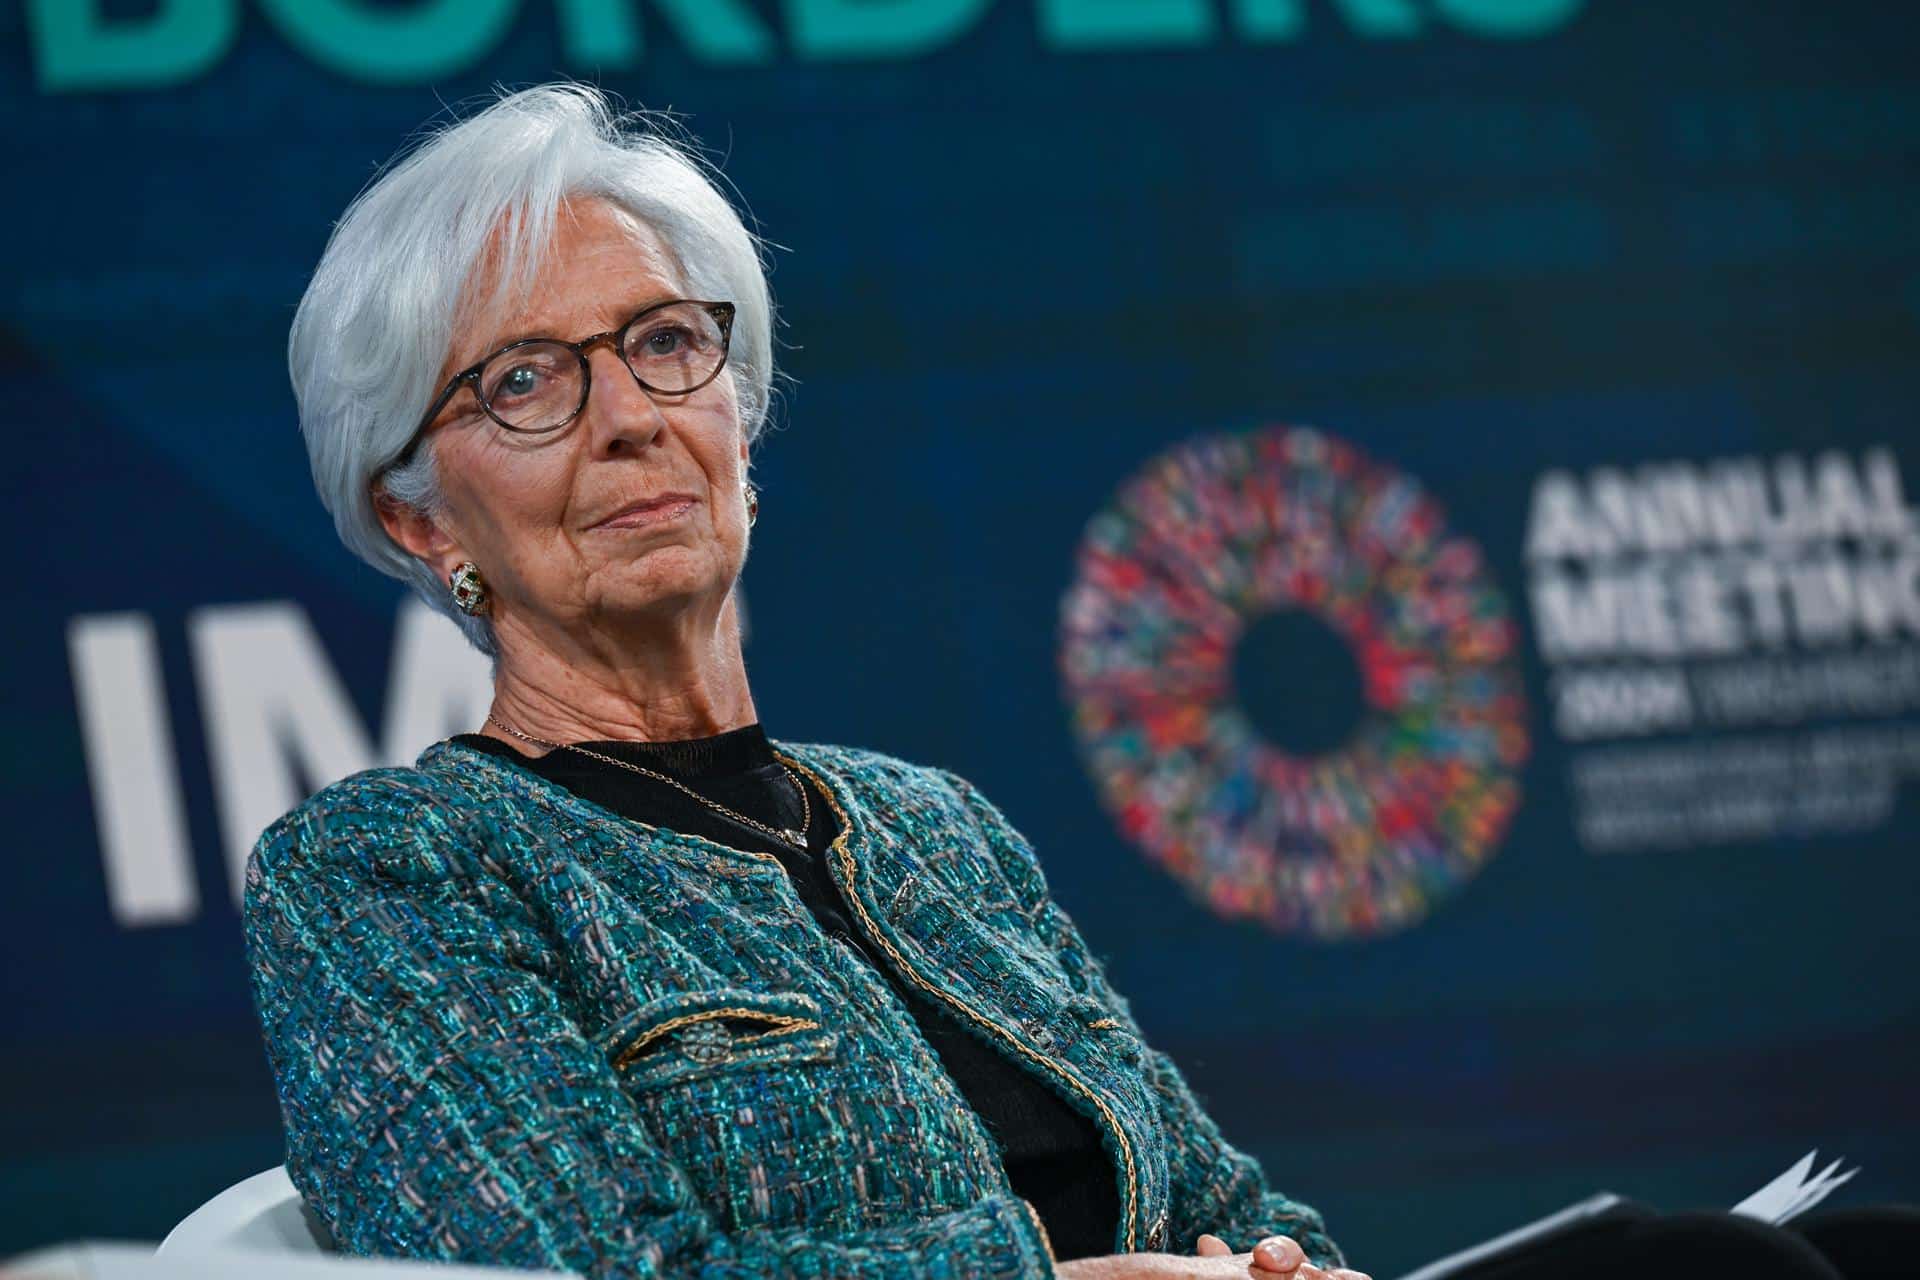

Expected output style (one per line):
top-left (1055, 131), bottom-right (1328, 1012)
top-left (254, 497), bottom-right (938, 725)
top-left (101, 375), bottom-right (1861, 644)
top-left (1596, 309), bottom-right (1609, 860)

top-left (288, 83), bottom-right (776, 658)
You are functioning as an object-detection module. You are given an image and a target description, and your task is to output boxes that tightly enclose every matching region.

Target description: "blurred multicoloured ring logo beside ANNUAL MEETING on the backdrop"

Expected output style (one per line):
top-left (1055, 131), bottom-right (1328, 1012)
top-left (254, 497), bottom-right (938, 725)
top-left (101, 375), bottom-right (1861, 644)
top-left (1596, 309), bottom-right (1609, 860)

top-left (1060, 426), bottom-right (1528, 940)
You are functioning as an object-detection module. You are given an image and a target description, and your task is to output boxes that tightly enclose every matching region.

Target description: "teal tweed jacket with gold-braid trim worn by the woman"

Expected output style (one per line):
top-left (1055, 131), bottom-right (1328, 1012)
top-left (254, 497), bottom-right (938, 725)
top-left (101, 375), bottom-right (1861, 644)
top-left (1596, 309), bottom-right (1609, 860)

top-left (244, 741), bottom-right (1342, 1280)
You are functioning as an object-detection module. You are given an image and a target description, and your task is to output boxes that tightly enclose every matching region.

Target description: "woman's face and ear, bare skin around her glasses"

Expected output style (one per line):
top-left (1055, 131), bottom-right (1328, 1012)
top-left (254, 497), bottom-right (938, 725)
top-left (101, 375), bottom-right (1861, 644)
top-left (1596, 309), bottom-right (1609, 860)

top-left (380, 200), bottom-right (747, 660)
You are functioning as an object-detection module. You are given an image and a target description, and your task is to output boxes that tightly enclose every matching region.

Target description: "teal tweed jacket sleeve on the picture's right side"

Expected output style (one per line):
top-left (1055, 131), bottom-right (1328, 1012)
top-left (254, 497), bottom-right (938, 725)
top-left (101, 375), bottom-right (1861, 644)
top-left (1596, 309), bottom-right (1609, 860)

top-left (941, 770), bottom-right (1346, 1267)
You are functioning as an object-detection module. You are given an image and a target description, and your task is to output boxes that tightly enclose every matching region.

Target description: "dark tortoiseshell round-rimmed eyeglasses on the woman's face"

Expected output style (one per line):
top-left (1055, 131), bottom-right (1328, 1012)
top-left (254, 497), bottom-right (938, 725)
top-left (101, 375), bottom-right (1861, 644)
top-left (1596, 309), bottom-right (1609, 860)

top-left (392, 297), bottom-right (733, 466)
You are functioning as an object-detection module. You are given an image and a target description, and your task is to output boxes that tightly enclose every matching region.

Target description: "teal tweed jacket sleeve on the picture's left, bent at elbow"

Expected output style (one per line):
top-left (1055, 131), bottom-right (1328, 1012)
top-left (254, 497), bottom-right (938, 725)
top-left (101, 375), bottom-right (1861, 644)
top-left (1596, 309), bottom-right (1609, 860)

top-left (244, 793), bottom-right (1052, 1280)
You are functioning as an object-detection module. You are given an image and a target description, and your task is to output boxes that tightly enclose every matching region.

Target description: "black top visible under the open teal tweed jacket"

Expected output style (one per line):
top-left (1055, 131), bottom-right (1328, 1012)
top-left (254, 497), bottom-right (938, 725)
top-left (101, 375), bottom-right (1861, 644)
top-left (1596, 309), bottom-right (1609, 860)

top-left (453, 723), bottom-right (1119, 1261)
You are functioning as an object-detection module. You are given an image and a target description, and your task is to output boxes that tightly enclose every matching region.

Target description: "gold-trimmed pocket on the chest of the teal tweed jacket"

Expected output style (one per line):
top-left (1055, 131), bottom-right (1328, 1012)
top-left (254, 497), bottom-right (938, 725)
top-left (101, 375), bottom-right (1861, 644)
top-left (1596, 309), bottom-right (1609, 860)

top-left (605, 986), bottom-right (839, 1084)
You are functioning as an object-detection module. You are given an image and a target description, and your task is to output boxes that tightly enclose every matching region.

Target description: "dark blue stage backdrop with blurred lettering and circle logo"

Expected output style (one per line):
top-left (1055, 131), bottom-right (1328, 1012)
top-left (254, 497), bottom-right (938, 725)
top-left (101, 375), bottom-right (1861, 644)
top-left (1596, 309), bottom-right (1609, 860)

top-left (0, 0), bottom-right (1920, 1276)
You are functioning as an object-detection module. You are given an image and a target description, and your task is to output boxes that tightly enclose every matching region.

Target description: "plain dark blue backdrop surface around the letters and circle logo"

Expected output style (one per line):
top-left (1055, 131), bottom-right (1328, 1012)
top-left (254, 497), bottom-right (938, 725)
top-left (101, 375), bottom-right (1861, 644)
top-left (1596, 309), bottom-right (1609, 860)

top-left (0, 0), bottom-right (1920, 1276)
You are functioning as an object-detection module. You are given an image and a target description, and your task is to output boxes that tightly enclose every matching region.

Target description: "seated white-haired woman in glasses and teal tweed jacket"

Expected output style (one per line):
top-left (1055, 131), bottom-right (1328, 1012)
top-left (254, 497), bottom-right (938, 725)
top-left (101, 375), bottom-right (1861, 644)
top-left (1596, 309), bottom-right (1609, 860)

top-left (244, 84), bottom-right (1359, 1280)
